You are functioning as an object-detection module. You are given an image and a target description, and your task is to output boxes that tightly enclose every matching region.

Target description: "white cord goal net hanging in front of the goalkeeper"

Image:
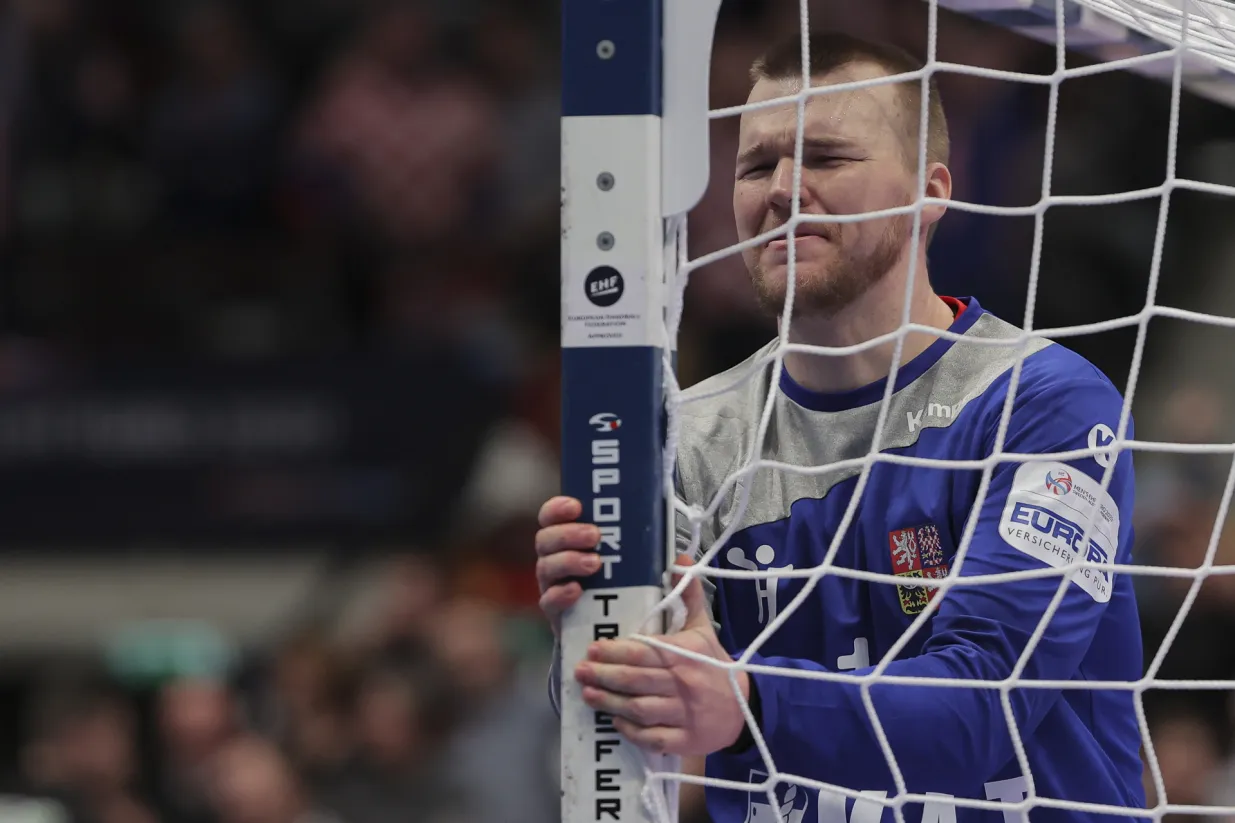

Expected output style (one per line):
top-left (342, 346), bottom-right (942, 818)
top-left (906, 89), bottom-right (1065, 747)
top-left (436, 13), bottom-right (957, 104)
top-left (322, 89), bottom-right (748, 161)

top-left (563, 0), bottom-right (1235, 823)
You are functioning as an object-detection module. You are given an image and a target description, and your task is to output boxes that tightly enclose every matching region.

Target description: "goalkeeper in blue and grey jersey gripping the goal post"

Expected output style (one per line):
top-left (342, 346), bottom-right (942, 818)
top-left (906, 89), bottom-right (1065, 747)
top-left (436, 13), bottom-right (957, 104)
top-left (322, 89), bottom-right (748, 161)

top-left (536, 28), bottom-right (1145, 823)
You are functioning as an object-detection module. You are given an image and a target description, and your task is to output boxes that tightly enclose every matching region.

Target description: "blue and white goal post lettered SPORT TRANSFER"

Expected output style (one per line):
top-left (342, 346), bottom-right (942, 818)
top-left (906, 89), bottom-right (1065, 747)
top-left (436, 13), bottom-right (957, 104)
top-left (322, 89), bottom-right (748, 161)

top-left (561, 0), bottom-right (720, 823)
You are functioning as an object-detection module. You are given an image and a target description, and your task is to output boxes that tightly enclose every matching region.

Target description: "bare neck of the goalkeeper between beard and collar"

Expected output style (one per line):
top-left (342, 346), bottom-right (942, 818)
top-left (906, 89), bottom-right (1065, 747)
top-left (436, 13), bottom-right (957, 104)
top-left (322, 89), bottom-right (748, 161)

top-left (784, 251), bottom-right (953, 392)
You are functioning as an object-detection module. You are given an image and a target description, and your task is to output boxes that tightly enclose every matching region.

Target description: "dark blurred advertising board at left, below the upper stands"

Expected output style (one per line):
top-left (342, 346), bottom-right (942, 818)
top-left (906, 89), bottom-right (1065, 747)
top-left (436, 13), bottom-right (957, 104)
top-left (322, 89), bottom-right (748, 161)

top-left (0, 351), bottom-right (501, 550)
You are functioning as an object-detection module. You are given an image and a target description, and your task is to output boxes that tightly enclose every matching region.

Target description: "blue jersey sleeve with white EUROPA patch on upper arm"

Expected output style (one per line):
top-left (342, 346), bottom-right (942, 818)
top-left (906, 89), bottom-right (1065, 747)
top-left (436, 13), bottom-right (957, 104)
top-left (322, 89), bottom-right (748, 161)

top-left (720, 372), bottom-right (1139, 793)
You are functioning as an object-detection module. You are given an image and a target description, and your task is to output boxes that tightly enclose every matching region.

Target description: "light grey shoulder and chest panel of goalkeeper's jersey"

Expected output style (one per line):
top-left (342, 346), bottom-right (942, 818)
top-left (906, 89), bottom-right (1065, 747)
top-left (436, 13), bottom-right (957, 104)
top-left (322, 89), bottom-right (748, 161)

top-left (676, 314), bottom-right (1053, 536)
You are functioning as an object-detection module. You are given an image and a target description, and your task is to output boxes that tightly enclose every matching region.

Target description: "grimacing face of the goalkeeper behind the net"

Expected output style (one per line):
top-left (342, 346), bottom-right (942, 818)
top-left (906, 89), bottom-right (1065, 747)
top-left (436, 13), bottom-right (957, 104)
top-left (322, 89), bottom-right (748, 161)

top-left (734, 63), bottom-right (925, 316)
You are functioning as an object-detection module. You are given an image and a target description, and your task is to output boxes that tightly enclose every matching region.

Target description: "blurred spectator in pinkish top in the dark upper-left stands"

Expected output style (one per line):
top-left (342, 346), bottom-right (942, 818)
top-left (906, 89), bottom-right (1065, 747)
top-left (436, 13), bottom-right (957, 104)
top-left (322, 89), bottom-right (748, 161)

top-left (293, 4), bottom-right (499, 245)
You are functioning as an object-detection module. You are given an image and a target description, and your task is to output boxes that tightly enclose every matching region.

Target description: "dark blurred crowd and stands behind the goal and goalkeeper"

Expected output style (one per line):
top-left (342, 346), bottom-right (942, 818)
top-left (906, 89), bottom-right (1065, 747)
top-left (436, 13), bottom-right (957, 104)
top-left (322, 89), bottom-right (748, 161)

top-left (0, 0), bottom-right (1235, 823)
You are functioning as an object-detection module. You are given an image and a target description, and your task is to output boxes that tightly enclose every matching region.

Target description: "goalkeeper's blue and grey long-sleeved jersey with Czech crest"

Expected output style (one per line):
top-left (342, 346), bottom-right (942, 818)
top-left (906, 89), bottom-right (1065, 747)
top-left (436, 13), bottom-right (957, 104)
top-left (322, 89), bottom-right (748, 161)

top-left (677, 300), bottom-right (1145, 823)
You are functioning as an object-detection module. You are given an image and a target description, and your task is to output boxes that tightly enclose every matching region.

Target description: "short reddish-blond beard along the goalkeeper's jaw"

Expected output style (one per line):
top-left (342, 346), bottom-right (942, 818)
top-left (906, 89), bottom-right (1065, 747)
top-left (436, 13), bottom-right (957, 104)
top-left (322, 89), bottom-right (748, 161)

top-left (751, 217), bottom-right (925, 318)
